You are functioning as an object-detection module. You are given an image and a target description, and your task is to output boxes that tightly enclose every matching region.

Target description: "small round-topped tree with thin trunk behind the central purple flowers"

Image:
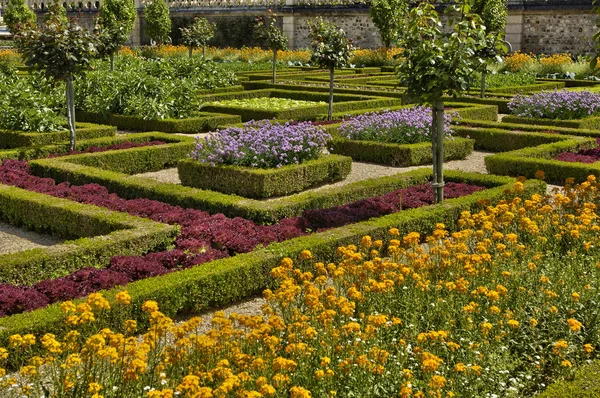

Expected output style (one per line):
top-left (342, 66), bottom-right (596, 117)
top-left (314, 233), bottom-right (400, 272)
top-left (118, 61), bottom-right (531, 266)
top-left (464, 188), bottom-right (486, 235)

top-left (309, 17), bottom-right (354, 120)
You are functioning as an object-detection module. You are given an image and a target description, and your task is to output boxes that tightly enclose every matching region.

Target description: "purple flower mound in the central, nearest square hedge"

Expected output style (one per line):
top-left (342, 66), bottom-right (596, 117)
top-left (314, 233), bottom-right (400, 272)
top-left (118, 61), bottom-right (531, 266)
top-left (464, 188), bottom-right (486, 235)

top-left (190, 120), bottom-right (331, 168)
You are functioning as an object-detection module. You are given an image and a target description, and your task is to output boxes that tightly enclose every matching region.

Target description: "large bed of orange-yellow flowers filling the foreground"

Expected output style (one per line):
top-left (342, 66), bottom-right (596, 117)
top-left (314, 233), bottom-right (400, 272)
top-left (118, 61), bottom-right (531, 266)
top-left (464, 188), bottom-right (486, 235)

top-left (0, 176), bottom-right (600, 398)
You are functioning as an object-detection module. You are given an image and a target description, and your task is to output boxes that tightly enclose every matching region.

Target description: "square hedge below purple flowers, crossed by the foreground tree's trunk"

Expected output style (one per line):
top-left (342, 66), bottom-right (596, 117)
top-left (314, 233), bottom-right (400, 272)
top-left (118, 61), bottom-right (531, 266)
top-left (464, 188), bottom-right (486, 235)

top-left (332, 136), bottom-right (474, 167)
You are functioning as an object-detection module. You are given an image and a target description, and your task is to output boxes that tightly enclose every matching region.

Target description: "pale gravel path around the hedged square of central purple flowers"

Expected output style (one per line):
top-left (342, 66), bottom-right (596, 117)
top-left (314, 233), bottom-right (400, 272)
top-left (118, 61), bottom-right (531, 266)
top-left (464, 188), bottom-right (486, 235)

top-left (136, 151), bottom-right (491, 195)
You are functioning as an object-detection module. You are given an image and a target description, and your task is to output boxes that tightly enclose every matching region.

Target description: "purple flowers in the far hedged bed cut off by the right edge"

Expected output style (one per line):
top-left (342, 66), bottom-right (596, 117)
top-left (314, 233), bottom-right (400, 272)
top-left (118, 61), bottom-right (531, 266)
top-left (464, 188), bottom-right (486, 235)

top-left (508, 90), bottom-right (600, 120)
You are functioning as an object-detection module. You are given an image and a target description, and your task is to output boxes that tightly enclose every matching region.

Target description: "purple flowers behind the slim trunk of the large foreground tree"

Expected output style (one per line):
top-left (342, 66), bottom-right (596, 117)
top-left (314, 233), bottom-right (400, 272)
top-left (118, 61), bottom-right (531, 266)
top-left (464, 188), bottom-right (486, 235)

top-left (338, 106), bottom-right (452, 144)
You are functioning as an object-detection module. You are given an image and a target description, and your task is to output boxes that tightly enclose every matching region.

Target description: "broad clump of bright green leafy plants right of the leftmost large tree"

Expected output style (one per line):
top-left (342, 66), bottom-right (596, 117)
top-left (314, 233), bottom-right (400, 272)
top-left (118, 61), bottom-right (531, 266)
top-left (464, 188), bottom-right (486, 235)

top-left (76, 57), bottom-right (236, 120)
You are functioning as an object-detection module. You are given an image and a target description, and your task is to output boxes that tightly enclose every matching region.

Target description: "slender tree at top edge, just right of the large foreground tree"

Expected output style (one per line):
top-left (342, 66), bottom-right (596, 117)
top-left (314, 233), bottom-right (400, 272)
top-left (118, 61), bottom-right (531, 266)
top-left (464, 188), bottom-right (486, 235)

top-left (471, 0), bottom-right (508, 98)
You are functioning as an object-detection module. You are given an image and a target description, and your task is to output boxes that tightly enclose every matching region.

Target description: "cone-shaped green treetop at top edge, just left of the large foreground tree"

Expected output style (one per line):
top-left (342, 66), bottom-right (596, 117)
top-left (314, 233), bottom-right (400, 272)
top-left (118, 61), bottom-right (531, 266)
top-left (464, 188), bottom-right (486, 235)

top-left (369, 0), bottom-right (409, 48)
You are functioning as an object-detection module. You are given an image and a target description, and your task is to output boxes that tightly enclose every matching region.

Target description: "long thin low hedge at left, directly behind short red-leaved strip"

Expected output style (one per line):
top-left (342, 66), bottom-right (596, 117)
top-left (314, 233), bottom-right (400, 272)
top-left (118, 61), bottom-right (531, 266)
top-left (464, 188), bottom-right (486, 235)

top-left (0, 132), bottom-right (188, 160)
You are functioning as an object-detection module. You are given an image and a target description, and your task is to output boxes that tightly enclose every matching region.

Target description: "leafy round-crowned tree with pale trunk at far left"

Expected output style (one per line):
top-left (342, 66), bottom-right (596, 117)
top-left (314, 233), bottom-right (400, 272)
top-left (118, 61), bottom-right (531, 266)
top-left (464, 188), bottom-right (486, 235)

top-left (15, 7), bottom-right (97, 150)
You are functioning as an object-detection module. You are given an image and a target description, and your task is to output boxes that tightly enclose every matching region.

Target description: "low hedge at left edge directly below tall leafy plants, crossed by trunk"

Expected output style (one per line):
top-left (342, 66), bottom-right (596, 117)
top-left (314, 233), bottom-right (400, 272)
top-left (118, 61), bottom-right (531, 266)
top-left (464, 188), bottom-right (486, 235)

top-left (0, 123), bottom-right (117, 149)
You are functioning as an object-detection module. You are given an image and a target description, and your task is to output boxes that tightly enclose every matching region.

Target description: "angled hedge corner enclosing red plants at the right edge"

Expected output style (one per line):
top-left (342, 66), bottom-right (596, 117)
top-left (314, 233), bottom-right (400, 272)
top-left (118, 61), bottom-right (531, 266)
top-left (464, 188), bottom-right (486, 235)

top-left (485, 136), bottom-right (600, 184)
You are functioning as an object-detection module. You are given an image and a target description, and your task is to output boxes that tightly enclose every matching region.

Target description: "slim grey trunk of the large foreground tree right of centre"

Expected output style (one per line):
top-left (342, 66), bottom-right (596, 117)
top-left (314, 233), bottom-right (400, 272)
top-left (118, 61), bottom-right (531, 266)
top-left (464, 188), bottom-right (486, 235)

top-left (431, 100), bottom-right (444, 203)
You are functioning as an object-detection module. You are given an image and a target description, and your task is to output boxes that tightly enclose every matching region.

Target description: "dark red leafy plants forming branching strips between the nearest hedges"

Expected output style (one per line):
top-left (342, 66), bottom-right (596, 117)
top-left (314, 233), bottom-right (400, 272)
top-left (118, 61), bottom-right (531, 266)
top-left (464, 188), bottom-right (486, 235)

top-left (0, 160), bottom-right (484, 316)
